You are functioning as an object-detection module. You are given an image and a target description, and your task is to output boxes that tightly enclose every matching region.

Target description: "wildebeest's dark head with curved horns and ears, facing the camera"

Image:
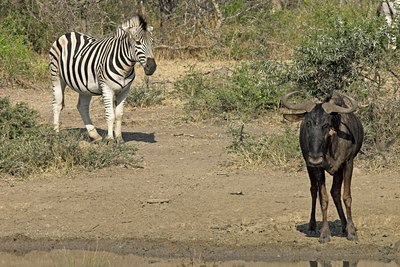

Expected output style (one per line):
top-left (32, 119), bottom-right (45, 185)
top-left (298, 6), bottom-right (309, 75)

top-left (282, 92), bottom-right (358, 167)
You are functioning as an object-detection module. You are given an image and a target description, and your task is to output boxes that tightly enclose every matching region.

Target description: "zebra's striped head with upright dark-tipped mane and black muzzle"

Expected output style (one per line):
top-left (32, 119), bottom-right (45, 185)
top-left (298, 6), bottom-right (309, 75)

top-left (120, 16), bottom-right (157, 75)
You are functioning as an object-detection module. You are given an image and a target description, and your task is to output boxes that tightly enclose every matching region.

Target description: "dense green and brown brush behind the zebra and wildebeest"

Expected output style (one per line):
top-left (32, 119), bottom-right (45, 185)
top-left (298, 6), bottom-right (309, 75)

top-left (0, 0), bottom-right (400, 176)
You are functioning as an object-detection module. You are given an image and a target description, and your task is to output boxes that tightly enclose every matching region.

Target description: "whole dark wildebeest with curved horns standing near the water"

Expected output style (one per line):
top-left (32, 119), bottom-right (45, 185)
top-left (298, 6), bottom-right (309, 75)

top-left (282, 92), bottom-right (364, 243)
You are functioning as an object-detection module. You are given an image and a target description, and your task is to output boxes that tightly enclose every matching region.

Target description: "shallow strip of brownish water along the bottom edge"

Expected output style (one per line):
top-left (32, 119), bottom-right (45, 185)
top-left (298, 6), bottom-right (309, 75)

top-left (0, 252), bottom-right (400, 267)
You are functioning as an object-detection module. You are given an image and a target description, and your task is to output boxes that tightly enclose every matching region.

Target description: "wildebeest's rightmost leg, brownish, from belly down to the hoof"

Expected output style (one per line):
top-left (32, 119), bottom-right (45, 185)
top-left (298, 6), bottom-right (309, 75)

top-left (343, 159), bottom-right (358, 240)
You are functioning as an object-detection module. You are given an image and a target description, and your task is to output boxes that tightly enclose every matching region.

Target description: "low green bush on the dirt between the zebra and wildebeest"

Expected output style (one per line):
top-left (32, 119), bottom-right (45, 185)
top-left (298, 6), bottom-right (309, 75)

top-left (174, 61), bottom-right (287, 118)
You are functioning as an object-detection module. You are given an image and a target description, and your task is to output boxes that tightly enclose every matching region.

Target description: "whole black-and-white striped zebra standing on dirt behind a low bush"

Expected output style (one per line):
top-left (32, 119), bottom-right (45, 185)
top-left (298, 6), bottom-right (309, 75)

top-left (49, 15), bottom-right (157, 143)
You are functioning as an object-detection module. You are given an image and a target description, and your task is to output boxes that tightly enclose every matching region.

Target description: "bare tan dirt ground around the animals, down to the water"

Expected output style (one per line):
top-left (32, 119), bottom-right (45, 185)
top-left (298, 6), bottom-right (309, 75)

top-left (0, 61), bottom-right (400, 266)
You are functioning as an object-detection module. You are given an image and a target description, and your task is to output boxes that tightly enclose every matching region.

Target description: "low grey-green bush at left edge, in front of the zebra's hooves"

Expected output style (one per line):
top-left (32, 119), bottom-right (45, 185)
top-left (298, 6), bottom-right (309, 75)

top-left (0, 99), bottom-right (140, 177)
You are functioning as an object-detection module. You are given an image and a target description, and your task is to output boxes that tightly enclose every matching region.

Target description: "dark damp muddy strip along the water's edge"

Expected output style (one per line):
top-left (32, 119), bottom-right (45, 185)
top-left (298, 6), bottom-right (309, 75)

top-left (0, 235), bottom-right (400, 263)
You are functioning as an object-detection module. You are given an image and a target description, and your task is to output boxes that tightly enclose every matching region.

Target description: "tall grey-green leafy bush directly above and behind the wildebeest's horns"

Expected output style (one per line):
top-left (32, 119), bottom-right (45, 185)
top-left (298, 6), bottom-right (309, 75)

top-left (291, 17), bottom-right (389, 97)
